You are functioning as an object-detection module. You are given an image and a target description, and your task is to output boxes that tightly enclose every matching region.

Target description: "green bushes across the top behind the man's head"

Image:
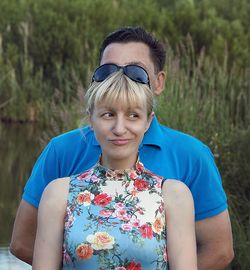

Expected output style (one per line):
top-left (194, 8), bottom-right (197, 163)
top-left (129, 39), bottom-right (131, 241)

top-left (0, 0), bottom-right (250, 121)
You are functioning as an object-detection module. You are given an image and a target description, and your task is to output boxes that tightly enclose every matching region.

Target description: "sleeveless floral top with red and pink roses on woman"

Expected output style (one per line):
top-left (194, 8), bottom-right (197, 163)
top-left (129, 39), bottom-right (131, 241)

top-left (62, 161), bottom-right (168, 270)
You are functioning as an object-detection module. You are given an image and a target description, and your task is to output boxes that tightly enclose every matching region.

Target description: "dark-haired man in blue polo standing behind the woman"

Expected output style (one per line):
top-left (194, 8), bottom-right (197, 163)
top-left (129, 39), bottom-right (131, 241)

top-left (10, 27), bottom-right (233, 270)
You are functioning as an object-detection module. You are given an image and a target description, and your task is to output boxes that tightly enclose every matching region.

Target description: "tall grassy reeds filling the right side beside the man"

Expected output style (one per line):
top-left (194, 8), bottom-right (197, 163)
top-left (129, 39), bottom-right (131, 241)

top-left (157, 37), bottom-right (250, 269)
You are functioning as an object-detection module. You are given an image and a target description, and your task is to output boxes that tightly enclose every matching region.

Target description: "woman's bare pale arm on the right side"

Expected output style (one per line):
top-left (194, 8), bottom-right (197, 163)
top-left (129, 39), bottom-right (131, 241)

top-left (162, 180), bottom-right (197, 270)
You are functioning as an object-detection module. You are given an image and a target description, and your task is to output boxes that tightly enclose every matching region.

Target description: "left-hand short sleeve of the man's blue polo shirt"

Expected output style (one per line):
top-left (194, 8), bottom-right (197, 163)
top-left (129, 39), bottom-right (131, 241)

top-left (22, 140), bottom-right (60, 208)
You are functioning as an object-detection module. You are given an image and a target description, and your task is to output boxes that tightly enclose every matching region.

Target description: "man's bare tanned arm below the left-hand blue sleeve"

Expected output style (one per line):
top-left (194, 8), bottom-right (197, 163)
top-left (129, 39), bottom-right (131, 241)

top-left (10, 200), bottom-right (37, 264)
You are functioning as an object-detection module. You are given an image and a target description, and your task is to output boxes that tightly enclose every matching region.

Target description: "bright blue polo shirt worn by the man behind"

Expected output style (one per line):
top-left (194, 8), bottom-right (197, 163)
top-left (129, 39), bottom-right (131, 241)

top-left (23, 117), bottom-right (227, 221)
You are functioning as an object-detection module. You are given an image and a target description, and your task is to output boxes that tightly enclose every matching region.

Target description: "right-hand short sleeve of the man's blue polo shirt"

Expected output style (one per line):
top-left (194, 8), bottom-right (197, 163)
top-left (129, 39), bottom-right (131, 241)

top-left (186, 145), bottom-right (228, 221)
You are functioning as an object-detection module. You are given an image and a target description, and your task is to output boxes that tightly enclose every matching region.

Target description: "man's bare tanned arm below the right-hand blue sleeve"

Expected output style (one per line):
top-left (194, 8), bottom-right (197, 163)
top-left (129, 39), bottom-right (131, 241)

top-left (195, 210), bottom-right (234, 270)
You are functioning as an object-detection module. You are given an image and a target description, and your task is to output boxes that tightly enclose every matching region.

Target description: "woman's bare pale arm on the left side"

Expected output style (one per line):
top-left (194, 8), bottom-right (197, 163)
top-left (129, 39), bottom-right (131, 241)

top-left (32, 178), bottom-right (69, 270)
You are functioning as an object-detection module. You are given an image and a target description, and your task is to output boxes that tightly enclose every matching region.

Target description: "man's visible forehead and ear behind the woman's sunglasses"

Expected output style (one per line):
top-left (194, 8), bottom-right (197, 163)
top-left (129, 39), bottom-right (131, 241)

top-left (100, 42), bottom-right (165, 95)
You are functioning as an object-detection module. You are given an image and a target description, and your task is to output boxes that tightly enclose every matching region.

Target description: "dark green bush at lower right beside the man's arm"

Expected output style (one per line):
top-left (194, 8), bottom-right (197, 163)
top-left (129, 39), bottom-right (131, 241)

top-left (221, 127), bottom-right (250, 269)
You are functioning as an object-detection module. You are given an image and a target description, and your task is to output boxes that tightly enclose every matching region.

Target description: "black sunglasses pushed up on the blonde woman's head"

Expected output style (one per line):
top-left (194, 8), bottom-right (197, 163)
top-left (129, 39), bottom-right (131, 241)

top-left (92, 64), bottom-right (150, 86)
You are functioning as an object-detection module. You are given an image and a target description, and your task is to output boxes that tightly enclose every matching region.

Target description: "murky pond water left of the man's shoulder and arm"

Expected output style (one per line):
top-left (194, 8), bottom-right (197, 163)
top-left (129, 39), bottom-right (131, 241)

top-left (0, 123), bottom-right (42, 269)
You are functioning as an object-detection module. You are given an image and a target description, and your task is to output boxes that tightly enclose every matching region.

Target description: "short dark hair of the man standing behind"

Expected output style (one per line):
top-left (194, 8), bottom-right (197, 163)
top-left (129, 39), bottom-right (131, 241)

top-left (99, 26), bottom-right (166, 71)
